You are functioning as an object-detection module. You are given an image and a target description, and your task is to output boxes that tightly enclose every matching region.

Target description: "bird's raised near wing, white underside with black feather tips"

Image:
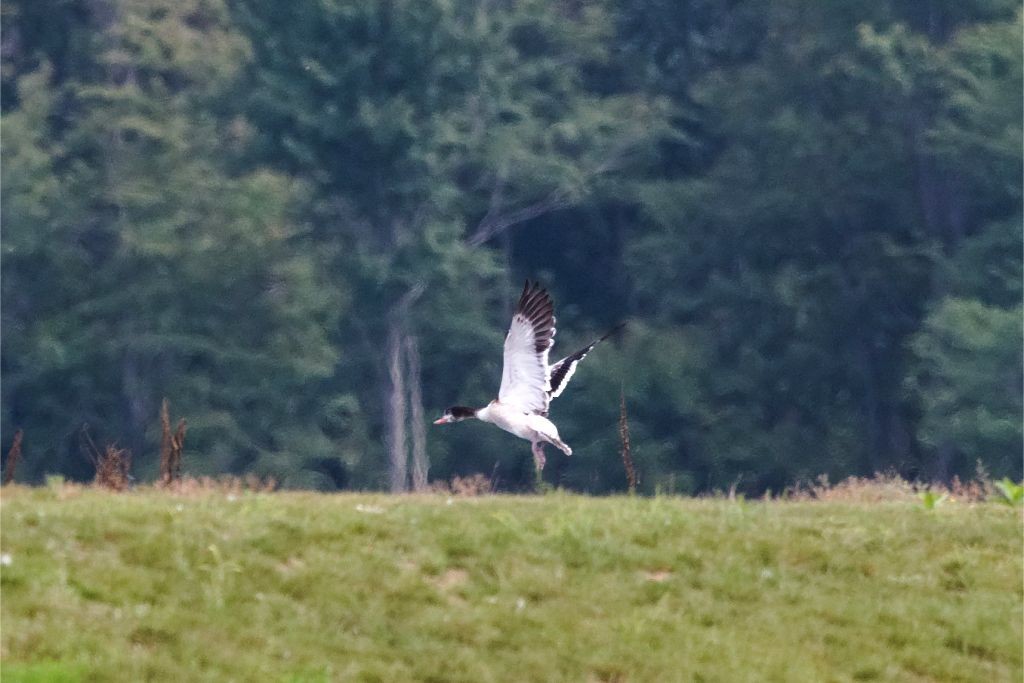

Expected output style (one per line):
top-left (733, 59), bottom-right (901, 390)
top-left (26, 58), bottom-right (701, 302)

top-left (498, 280), bottom-right (555, 415)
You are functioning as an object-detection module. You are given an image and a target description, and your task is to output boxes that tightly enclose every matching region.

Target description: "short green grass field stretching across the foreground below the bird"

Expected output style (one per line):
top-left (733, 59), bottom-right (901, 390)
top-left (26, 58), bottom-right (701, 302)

top-left (0, 486), bottom-right (1022, 683)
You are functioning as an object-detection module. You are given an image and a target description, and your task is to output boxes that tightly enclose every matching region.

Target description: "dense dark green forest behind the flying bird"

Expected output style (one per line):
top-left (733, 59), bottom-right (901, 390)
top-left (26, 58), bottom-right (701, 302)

top-left (0, 0), bottom-right (1024, 494)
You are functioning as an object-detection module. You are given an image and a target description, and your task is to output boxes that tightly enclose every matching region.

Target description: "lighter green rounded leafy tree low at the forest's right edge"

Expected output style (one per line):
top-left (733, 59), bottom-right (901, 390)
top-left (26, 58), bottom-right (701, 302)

top-left (907, 220), bottom-right (1024, 476)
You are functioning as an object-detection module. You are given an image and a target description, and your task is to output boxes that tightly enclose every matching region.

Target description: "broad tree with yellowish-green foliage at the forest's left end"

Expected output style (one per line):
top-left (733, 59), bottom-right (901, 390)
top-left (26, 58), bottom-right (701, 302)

top-left (3, 3), bottom-right (343, 478)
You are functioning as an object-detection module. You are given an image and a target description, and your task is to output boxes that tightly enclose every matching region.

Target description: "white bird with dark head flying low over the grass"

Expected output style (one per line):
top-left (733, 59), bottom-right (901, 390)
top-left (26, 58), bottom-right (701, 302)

top-left (434, 280), bottom-right (623, 470)
